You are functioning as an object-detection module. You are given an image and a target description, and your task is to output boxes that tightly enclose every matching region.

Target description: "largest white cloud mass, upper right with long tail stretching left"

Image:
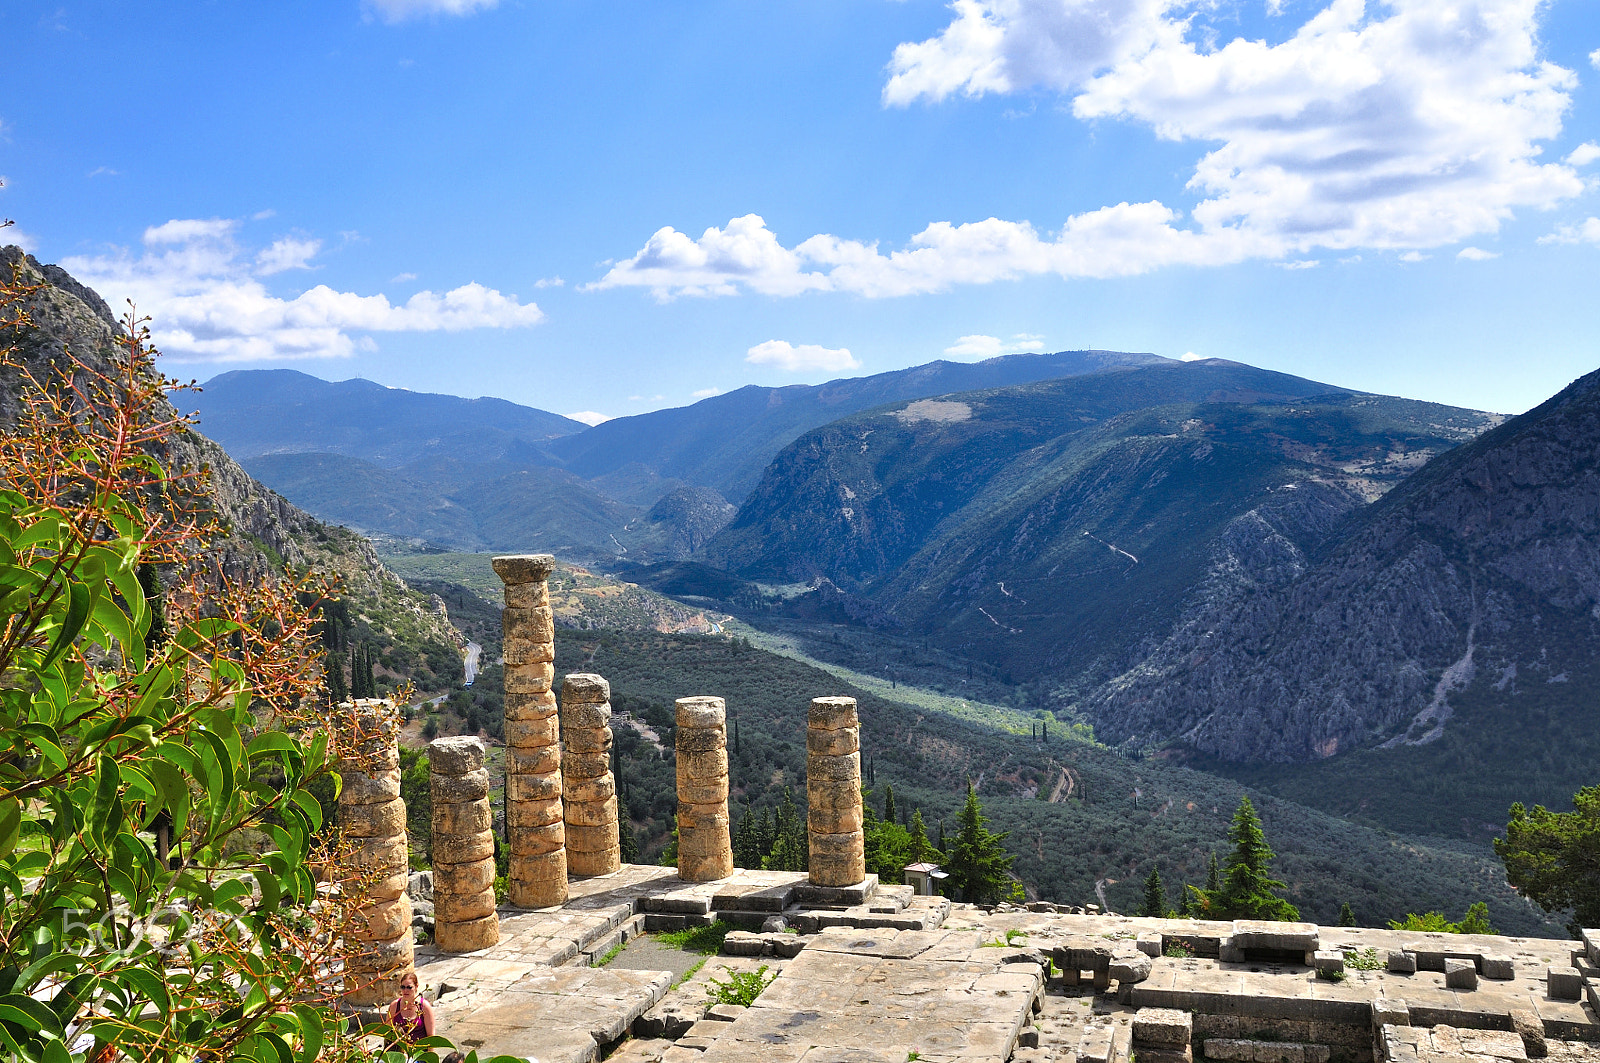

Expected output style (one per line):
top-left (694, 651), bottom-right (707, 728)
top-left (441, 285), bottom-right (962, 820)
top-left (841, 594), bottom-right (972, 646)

top-left (590, 0), bottom-right (1587, 299)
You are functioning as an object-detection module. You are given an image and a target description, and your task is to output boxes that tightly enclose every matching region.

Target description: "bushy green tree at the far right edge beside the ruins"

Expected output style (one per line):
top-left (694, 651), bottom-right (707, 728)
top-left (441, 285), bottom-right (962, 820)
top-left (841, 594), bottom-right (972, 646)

top-left (1494, 786), bottom-right (1600, 937)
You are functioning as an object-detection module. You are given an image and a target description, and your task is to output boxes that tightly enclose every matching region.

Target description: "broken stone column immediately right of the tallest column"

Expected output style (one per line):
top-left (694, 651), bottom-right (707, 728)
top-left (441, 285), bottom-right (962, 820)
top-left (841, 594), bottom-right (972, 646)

top-left (562, 672), bottom-right (622, 877)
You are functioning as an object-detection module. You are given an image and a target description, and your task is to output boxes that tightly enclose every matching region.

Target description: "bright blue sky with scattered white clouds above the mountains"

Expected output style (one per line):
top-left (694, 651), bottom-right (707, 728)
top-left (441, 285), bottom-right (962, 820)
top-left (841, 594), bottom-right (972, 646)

top-left (0, 0), bottom-right (1600, 421)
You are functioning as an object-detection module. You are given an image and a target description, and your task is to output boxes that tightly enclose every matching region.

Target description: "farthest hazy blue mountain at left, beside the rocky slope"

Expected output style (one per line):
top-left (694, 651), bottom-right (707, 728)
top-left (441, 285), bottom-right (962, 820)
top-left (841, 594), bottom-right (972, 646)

top-left (186, 370), bottom-right (587, 467)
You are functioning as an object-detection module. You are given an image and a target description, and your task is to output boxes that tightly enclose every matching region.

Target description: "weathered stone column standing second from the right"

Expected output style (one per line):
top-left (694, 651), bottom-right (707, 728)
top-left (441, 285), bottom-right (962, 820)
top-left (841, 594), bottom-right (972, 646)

top-left (675, 698), bottom-right (733, 882)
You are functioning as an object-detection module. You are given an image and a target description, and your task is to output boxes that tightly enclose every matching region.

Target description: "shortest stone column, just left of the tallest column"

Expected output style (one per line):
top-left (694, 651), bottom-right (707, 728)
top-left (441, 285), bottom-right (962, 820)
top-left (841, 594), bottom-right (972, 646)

top-left (427, 736), bottom-right (499, 953)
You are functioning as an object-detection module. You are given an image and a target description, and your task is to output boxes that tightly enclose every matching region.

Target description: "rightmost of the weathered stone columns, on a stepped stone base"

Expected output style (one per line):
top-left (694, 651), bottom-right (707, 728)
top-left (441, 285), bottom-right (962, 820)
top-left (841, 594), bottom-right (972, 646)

top-left (805, 698), bottom-right (867, 885)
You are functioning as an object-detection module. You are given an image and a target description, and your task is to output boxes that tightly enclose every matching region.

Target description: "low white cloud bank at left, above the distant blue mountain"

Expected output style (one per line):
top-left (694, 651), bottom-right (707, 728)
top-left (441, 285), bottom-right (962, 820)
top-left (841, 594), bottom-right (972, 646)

top-left (61, 218), bottom-right (544, 362)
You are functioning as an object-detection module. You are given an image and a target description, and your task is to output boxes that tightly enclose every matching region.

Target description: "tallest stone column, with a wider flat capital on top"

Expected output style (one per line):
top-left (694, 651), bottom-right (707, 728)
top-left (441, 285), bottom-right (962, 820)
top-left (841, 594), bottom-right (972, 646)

top-left (494, 554), bottom-right (566, 908)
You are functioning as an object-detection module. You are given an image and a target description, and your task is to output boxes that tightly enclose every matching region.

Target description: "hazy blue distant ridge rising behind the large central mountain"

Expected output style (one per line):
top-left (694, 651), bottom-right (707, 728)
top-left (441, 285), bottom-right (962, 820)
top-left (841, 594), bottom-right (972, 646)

top-left (546, 351), bottom-right (1171, 503)
